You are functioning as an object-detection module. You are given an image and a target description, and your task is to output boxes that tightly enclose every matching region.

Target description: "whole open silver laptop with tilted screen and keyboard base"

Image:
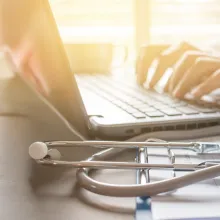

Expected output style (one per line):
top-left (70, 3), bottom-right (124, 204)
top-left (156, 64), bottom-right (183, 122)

top-left (3, 1), bottom-right (220, 140)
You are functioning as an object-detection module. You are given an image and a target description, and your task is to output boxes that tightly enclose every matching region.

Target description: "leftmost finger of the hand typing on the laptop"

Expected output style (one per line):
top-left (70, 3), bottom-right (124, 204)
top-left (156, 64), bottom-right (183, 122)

top-left (136, 45), bottom-right (169, 85)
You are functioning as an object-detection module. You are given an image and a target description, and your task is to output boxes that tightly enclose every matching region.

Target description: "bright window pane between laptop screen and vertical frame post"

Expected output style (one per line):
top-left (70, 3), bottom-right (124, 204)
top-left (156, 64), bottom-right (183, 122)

top-left (50, 0), bottom-right (135, 53)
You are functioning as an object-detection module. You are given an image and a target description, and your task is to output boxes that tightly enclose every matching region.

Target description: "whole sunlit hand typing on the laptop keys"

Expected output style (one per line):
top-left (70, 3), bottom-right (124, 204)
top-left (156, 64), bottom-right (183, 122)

top-left (136, 43), bottom-right (220, 99)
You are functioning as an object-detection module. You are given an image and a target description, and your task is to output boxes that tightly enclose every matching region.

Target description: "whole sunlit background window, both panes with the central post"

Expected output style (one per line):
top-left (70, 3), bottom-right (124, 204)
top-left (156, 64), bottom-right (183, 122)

top-left (50, 0), bottom-right (220, 59)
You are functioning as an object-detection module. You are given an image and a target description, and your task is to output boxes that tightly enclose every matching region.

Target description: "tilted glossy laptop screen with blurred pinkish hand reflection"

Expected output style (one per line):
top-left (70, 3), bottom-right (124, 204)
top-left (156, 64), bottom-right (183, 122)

top-left (0, 0), bottom-right (88, 136)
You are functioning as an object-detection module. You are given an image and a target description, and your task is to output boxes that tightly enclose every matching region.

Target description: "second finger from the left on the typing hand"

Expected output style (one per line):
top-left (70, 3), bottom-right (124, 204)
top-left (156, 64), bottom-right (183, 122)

top-left (149, 43), bottom-right (198, 88)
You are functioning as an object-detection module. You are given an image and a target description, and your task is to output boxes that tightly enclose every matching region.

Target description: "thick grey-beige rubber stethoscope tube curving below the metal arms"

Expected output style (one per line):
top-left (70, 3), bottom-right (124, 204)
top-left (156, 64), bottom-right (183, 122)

top-left (76, 149), bottom-right (220, 197)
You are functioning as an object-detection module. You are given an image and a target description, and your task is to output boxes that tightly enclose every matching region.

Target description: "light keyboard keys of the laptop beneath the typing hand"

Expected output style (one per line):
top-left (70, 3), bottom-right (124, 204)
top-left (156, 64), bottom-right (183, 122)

top-left (76, 74), bottom-right (220, 119)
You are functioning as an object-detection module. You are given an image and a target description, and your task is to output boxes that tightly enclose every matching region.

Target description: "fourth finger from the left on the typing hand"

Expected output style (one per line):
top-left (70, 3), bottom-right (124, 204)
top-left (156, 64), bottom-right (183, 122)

top-left (173, 57), bottom-right (220, 98)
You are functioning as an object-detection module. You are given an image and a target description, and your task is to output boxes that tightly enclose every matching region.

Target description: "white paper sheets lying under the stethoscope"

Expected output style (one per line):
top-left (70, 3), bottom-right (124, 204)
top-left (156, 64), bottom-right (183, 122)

top-left (148, 144), bottom-right (220, 220)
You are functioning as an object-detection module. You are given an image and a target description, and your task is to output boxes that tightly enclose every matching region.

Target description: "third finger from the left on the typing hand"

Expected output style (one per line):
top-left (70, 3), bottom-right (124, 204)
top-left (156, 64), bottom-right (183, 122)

top-left (167, 51), bottom-right (206, 93)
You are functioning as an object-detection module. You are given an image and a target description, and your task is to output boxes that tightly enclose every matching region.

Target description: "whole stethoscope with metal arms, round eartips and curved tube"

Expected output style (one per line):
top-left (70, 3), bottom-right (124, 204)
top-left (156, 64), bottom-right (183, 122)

top-left (29, 139), bottom-right (220, 197)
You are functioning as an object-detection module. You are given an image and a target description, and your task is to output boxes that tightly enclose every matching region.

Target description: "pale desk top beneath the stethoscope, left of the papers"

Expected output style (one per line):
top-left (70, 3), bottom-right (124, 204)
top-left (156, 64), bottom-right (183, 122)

top-left (0, 117), bottom-right (135, 220)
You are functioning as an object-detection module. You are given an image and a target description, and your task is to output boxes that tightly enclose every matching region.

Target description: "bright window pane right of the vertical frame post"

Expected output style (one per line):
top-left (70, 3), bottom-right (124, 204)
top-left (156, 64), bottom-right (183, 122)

top-left (150, 0), bottom-right (220, 49)
